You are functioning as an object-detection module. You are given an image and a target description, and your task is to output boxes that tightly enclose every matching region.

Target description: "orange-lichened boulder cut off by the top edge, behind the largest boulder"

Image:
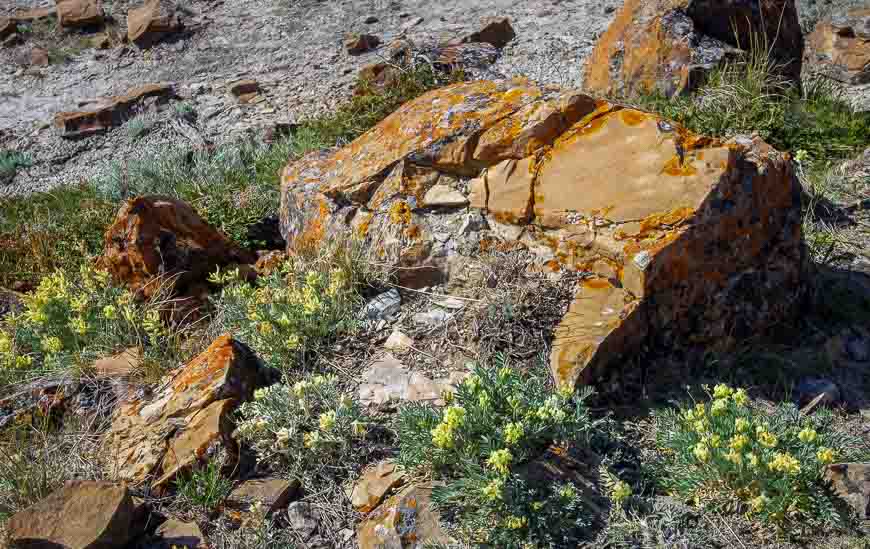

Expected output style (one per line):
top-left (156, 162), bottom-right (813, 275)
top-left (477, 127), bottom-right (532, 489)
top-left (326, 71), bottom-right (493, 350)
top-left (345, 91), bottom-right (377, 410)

top-left (584, 0), bottom-right (803, 96)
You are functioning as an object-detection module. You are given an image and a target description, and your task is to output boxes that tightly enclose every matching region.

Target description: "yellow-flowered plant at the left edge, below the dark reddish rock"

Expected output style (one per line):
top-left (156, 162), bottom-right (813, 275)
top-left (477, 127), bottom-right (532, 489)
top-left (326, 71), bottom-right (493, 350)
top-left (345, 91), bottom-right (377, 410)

top-left (0, 266), bottom-right (174, 387)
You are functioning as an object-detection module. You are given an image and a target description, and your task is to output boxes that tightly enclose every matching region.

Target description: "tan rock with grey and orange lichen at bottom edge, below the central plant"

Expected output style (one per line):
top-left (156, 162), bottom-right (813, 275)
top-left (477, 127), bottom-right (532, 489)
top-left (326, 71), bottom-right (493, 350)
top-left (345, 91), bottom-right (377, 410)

top-left (356, 484), bottom-right (453, 549)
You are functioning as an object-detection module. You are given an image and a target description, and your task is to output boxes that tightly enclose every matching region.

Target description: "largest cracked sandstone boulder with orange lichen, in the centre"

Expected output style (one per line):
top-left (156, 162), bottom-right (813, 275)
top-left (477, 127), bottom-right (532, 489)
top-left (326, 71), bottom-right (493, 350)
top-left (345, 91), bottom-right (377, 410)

top-left (281, 80), bottom-right (802, 390)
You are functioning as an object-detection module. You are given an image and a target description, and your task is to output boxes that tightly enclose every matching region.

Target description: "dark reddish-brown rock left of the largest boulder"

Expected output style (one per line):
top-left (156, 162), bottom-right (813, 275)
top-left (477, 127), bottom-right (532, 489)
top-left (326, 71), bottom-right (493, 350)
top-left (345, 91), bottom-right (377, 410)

top-left (100, 196), bottom-right (257, 297)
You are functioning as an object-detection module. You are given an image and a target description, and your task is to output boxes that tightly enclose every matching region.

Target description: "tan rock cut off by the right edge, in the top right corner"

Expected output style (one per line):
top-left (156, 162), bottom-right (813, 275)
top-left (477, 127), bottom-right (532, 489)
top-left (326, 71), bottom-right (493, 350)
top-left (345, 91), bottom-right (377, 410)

top-left (805, 9), bottom-right (870, 84)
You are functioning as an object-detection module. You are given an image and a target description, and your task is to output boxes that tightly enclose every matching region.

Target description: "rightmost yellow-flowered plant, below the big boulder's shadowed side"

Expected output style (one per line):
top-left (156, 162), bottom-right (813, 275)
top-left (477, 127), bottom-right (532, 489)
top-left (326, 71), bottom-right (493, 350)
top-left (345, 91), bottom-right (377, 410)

top-left (657, 385), bottom-right (867, 528)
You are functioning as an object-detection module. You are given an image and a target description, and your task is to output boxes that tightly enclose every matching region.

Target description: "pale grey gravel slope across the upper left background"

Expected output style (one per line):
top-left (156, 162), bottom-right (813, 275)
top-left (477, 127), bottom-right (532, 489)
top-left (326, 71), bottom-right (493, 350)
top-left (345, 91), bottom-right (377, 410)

top-left (0, 0), bottom-right (621, 196)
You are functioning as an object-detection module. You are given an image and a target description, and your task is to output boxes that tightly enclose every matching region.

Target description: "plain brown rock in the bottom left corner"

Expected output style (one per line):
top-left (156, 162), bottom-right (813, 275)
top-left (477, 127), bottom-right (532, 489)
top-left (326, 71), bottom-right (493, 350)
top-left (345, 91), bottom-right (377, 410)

top-left (7, 481), bottom-right (134, 549)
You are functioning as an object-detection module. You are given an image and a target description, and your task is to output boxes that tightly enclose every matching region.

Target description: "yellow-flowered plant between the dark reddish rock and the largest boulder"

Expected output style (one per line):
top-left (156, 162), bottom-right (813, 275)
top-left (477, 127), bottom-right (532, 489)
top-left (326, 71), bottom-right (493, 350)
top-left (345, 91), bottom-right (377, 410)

top-left (211, 249), bottom-right (368, 370)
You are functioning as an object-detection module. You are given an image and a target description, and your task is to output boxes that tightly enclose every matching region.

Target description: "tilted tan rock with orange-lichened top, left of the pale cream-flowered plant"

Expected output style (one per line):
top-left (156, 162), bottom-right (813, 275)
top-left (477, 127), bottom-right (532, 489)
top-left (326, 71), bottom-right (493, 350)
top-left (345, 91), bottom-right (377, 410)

top-left (104, 336), bottom-right (274, 488)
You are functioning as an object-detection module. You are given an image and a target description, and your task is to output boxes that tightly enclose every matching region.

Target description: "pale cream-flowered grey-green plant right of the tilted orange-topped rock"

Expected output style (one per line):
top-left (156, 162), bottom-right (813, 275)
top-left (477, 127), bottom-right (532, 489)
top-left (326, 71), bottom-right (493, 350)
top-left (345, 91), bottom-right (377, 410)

top-left (238, 375), bottom-right (368, 488)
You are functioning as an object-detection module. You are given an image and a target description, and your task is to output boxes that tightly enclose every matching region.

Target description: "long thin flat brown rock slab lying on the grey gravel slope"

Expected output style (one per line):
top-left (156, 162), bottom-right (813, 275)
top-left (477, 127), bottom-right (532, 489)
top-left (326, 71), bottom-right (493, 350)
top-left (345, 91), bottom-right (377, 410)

top-left (54, 83), bottom-right (174, 137)
